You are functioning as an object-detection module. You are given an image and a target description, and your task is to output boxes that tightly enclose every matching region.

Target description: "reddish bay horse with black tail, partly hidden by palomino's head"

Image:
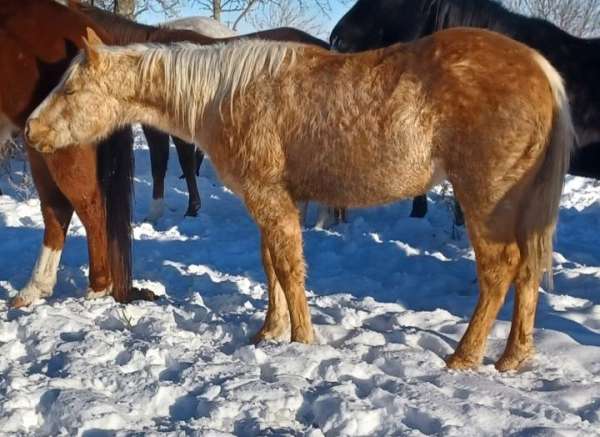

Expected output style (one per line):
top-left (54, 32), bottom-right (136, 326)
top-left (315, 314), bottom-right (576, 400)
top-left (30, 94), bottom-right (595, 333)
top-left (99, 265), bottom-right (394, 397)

top-left (0, 0), bottom-right (155, 307)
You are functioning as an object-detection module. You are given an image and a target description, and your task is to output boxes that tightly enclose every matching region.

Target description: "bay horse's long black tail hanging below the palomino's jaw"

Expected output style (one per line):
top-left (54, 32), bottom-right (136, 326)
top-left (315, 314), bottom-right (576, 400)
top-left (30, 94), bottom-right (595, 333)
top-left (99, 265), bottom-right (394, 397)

top-left (98, 126), bottom-right (134, 302)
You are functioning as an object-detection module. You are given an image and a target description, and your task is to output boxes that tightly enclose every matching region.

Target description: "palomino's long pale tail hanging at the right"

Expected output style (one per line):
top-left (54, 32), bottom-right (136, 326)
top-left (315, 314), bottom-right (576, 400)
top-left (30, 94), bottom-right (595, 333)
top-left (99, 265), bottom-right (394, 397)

top-left (519, 52), bottom-right (575, 289)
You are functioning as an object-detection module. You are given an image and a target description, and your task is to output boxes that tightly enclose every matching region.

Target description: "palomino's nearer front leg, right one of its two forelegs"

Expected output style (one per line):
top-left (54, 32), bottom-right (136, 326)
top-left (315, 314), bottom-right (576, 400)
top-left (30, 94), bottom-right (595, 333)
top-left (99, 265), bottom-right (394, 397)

top-left (244, 187), bottom-right (314, 343)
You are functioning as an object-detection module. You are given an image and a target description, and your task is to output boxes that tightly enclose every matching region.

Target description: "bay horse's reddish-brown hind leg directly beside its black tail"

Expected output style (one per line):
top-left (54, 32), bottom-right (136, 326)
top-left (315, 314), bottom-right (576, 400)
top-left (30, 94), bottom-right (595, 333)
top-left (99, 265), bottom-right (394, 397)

top-left (44, 147), bottom-right (111, 297)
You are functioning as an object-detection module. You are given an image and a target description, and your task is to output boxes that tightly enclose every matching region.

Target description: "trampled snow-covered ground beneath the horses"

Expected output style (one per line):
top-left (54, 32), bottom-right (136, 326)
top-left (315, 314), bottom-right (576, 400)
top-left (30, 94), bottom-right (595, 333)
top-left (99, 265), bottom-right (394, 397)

top-left (0, 127), bottom-right (600, 436)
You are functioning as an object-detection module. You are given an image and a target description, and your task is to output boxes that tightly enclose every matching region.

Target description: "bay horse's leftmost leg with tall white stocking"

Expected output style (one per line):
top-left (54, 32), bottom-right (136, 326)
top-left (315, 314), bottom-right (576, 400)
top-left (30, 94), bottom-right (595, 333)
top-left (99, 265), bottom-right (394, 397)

top-left (10, 147), bottom-right (73, 308)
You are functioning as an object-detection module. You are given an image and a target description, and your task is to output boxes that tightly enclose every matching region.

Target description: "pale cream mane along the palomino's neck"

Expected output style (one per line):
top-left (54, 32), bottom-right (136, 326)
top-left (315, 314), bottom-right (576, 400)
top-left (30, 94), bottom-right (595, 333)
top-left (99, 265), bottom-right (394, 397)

top-left (129, 40), bottom-right (302, 138)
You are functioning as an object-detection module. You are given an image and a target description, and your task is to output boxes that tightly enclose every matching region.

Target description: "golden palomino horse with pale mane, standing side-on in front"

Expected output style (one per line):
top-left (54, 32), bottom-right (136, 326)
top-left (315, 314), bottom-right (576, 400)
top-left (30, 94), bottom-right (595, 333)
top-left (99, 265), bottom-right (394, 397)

top-left (25, 29), bottom-right (574, 370)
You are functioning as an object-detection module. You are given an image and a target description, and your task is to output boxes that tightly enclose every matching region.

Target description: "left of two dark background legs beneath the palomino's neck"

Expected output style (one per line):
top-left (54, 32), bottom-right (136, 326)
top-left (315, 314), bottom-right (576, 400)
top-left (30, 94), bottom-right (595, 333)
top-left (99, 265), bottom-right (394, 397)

top-left (142, 125), bottom-right (169, 222)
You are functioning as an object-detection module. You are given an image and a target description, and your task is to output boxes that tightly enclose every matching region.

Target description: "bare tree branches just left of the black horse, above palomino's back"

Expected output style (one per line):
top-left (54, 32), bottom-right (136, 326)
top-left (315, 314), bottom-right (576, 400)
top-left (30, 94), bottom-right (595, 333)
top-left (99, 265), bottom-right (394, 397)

top-left (247, 0), bottom-right (325, 36)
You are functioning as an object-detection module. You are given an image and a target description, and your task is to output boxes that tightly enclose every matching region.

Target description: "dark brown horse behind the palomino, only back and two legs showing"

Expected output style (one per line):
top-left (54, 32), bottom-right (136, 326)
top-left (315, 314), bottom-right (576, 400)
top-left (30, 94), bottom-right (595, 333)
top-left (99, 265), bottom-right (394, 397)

top-left (69, 0), bottom-right (329, 220)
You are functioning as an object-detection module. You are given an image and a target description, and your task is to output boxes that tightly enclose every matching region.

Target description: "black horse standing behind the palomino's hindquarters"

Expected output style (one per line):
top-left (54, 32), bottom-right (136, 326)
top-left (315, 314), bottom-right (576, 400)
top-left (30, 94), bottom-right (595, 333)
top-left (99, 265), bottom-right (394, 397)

top-left (331, 0), bottom-right (600, 217)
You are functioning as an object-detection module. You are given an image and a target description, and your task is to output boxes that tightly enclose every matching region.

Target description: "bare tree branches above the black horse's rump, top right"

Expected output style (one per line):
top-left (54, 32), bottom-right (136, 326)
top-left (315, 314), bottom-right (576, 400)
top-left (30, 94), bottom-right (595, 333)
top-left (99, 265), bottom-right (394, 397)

top-left (505, 0), bottom-right (600, 37)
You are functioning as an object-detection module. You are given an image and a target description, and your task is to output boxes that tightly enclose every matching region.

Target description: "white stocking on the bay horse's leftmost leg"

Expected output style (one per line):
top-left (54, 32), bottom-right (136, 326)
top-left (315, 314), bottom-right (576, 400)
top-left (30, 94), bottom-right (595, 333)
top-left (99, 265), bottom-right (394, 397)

top-left (17, 245), bottom-right (62, 305)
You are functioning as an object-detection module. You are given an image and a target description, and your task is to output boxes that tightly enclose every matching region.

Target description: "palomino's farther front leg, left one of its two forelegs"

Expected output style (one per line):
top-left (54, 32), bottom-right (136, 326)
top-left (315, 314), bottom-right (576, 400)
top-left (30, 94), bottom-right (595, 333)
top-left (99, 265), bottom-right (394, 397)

top-left (253, 236), bottom-right (290, 343)
